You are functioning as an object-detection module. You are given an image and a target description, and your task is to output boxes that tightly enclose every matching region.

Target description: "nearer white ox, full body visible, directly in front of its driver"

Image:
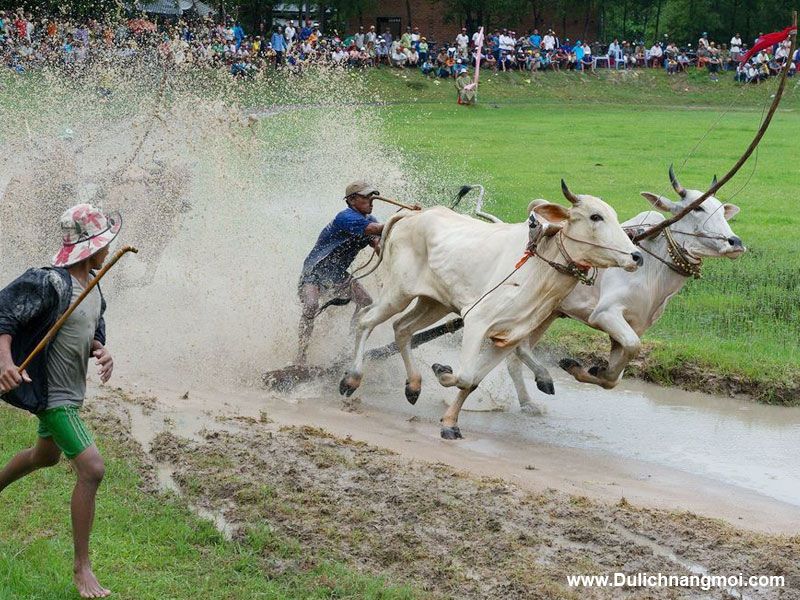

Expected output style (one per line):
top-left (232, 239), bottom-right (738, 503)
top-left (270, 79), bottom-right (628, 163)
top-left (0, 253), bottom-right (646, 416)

top-left (339, 181), bottom-right (642, 439)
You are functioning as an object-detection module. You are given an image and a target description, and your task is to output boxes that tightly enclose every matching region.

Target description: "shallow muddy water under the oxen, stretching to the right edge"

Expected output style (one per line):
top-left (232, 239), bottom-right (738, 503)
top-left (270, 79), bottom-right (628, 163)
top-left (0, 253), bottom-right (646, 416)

top-left (350, 353), bottom-right (800, 510)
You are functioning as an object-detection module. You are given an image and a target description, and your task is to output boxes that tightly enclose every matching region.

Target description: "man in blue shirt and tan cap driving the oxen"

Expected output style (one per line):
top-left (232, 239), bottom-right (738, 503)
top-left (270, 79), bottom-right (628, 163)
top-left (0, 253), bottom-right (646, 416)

top-left (296, 181), bottom-right (383, 365)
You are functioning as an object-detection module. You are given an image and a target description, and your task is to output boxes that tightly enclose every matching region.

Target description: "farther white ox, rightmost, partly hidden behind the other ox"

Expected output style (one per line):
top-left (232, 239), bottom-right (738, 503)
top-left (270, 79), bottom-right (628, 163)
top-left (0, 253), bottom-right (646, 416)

top-left (508, 168), bottom-right (746, 406)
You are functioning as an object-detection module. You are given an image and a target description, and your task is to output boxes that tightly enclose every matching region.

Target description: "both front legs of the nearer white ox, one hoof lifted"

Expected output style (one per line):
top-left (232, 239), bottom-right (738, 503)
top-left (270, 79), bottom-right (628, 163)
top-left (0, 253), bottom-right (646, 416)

top-left (432, 328), bottom-right (513, 440)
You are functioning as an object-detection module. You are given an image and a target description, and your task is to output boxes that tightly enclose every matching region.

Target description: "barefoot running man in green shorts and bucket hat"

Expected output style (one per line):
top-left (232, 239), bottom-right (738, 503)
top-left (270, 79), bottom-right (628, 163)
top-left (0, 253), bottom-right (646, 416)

top-left (0, 204), bottom-right (121, 598)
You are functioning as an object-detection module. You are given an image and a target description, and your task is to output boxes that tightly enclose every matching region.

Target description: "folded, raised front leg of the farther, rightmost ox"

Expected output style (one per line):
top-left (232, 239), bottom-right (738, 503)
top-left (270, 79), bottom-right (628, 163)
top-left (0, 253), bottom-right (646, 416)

top-left (559, 310), bottom-right (642, 390)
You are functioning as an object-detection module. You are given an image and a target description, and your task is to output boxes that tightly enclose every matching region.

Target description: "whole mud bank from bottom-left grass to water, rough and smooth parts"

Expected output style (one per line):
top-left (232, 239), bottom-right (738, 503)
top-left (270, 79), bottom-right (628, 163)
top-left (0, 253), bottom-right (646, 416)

top-left (84, 386), bottom-right (800, 598)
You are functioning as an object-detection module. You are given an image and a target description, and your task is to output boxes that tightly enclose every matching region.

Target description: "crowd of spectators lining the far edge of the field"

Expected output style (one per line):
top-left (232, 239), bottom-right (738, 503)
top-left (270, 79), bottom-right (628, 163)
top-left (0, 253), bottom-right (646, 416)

top-left (0, 9), bottom-right (800, 83)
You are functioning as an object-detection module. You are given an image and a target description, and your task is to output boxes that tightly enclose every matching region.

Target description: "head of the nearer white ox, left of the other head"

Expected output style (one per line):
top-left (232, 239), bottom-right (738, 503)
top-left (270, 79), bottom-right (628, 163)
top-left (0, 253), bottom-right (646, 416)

top-left (533, 180), bottom-right (642, 271)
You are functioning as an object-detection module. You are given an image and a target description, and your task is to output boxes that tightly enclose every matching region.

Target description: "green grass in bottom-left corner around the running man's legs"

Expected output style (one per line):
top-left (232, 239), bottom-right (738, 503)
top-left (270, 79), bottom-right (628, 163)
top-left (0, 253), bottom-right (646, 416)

top-left (0, 405), bottom-right (414, 600)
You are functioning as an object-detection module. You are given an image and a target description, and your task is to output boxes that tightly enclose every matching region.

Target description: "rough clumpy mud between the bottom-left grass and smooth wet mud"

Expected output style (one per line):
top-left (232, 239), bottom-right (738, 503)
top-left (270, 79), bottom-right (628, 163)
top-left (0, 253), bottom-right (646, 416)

top-left (87, 390), bottom-right (800, 599)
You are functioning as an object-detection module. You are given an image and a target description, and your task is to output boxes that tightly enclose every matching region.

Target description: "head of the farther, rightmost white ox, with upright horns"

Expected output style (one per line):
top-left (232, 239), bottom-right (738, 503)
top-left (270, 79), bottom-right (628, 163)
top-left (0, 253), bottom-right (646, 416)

top-left (642, 167), bottom-right (747, 259)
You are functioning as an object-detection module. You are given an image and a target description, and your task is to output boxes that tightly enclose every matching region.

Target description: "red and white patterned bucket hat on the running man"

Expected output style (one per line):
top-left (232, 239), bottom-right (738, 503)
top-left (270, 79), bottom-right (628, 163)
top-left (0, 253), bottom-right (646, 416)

top-left (53, 204), bottom-right (122, 267)
